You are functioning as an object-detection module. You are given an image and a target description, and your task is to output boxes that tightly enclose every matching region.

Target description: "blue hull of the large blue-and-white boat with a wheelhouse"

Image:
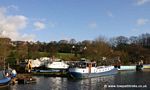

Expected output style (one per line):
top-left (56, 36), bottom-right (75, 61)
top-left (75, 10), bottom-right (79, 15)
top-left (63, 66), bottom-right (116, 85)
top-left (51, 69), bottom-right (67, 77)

top-left (69, 68), bottom-right (118, 78)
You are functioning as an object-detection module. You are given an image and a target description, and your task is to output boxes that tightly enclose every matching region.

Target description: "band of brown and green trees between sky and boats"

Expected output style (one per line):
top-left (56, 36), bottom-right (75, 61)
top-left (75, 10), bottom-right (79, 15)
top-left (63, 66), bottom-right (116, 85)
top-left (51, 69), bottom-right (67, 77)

top-left (0, 33), bottom-right (150, 65)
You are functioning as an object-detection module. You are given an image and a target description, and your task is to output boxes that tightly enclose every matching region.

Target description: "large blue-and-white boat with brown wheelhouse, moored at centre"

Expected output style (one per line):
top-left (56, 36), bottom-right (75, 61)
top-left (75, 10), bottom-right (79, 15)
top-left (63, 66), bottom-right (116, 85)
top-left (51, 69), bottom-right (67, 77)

top-left (69, 61), bottom-right (118, 78)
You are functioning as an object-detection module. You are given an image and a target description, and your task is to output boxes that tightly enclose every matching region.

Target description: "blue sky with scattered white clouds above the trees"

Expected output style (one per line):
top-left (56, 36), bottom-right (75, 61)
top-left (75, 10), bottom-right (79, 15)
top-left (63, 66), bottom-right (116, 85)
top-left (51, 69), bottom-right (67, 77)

top-left (0, 0), bottom-right (150, 42)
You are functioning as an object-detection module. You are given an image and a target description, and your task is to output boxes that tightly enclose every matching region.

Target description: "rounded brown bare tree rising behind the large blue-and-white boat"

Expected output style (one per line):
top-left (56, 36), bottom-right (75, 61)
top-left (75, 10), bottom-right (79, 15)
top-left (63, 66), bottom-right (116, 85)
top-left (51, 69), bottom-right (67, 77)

top-left (84, 37), bottom-right (111, 64)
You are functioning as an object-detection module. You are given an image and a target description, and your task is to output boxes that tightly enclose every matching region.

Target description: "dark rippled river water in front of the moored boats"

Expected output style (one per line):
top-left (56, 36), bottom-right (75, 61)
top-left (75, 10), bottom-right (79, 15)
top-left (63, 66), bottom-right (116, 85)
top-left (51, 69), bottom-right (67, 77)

top-left (0, 71), bottom-right (150, 90)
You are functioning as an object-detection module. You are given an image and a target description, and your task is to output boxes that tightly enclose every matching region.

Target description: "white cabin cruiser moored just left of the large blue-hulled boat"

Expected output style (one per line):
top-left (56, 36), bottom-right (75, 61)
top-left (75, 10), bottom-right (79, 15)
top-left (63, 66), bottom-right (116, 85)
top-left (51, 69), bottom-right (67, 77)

top-left (46, 59), bottom-right (69, 69)
